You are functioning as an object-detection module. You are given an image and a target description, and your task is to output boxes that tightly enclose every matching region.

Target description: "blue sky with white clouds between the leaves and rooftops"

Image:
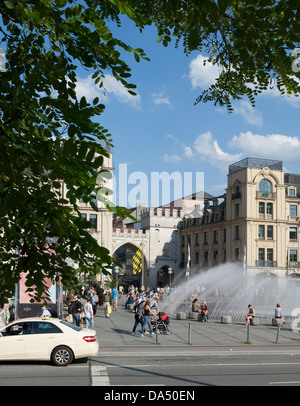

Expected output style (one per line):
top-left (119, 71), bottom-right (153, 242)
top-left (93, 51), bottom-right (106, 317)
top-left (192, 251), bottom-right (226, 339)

top-left (77, 18), bottom-right (300, 206)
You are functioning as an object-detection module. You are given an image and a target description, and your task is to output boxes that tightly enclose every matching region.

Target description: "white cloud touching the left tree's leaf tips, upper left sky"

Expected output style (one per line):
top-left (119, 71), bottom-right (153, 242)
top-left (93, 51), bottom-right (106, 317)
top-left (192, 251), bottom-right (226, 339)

top-left (76, 74), bottom-right (141, 108)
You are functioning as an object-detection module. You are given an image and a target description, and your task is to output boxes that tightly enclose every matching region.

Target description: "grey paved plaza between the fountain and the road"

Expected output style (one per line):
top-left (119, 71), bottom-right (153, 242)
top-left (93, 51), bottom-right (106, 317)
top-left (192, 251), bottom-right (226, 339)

top-left (95, 298), bottom-right (300, 357)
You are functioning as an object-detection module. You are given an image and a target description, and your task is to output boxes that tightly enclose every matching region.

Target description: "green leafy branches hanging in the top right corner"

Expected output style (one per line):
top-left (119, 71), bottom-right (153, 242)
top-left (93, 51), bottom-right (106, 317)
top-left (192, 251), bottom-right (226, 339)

top-left (130, 0), bottom-right (300, 111)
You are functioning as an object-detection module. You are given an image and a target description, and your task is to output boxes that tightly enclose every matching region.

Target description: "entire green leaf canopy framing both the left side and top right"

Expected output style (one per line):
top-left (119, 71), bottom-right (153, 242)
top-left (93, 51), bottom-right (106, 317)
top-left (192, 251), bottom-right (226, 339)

top-left (0, 0), bottom-right (300, 296)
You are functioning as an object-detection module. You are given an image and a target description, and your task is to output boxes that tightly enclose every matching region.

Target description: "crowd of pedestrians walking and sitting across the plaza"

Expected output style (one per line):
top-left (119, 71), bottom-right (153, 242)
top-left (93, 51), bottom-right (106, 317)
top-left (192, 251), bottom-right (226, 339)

top-left (0, 285), bottom-right (284, 337)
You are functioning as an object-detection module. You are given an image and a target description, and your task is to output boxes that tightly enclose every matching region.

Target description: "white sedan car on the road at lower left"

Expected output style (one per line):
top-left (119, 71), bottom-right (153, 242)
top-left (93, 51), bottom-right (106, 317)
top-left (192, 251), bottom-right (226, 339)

top-left (0, 317), bottom-right (99, 366)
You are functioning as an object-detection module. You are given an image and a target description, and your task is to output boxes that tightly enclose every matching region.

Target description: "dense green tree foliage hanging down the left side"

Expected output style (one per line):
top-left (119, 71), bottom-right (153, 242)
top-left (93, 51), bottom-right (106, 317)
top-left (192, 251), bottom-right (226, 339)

top-left (0, 0), bottom-right (145, 299)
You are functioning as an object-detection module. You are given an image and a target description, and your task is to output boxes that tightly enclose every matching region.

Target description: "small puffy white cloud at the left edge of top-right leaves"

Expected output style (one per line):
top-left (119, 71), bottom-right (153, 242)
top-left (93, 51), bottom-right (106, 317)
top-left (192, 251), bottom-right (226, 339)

top-left (189, 54), bottom-right (220, 89)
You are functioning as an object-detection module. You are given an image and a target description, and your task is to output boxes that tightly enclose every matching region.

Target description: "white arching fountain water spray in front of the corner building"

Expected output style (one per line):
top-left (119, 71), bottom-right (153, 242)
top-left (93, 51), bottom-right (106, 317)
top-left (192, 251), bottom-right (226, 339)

top-left (160, 263), bottom-right (300, 321)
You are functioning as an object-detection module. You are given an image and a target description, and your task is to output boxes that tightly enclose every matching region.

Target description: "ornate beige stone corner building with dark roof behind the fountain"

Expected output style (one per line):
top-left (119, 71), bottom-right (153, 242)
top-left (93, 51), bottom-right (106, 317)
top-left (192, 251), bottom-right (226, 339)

top-left (180, 158), bottom-right (300, 278)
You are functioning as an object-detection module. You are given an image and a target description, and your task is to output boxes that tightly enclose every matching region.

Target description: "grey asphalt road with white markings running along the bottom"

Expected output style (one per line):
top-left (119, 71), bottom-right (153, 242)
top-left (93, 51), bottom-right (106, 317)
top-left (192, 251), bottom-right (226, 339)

top-left (0, 354), bottom-right (300, 386)
